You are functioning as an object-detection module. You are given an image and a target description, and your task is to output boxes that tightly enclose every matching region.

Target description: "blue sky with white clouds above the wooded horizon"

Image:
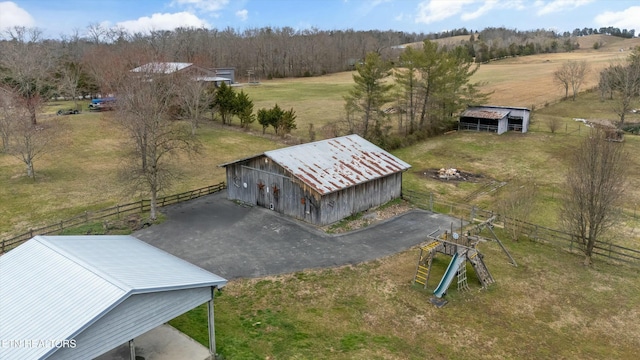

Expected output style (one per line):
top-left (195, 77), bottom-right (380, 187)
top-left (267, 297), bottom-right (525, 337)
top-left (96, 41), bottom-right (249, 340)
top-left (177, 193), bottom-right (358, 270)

top-left (0, 0), bottom-right (640, 38)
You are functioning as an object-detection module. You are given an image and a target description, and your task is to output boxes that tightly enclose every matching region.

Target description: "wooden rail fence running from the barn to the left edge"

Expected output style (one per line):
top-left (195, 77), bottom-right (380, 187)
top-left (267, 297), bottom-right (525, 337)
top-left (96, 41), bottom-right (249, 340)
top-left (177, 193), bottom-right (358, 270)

top-left (0, 182), bottom-right (226, 254)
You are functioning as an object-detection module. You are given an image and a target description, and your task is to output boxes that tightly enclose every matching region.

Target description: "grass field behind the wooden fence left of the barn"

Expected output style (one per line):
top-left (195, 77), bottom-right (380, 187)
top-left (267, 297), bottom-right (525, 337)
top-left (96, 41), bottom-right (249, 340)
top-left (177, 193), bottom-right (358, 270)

top-left (0, 112), bottom-right (284, 238)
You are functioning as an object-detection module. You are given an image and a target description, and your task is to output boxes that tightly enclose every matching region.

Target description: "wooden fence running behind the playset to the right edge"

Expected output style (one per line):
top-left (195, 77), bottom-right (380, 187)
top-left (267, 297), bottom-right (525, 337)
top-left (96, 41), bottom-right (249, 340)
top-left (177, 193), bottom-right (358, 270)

top-left (402, 190), bottom-right (640, 265)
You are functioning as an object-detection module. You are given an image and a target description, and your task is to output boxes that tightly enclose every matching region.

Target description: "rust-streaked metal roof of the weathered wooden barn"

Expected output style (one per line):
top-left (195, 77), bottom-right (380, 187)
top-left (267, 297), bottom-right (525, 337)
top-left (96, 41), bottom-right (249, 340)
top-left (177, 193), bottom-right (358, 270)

top-left (264, 135), bottom-right (411, 195)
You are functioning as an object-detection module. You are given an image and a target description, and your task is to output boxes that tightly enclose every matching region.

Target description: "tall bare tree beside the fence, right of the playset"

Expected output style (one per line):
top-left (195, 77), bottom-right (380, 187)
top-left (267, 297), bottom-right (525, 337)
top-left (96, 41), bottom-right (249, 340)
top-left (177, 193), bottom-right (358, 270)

top-left (560, 129), bottom-right (627, 265)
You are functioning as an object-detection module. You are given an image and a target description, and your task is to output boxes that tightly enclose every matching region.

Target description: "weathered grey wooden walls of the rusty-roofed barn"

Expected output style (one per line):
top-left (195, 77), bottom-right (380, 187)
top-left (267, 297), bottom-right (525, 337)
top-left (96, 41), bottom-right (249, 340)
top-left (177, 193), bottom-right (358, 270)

top-left (226, 156), bottom-right (402, 225)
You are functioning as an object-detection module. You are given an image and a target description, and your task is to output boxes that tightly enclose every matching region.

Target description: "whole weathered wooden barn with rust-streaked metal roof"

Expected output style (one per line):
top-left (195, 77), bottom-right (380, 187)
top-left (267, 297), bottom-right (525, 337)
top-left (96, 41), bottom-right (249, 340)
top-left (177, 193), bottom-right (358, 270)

top-left (220, 135), bottom-right (411, 225)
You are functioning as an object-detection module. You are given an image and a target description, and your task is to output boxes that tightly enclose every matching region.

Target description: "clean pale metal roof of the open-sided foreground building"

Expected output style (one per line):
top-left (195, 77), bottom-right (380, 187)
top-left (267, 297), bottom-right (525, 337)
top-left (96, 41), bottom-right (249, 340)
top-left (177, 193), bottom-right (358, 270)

top-left (0, 236), bottom-right (227, 360)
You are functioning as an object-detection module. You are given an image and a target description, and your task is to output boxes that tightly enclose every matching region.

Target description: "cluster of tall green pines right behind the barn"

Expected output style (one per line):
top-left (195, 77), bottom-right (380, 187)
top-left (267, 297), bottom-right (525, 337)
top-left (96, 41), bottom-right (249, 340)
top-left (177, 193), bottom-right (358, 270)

top-left (342, 40), bottom-right (489, 149)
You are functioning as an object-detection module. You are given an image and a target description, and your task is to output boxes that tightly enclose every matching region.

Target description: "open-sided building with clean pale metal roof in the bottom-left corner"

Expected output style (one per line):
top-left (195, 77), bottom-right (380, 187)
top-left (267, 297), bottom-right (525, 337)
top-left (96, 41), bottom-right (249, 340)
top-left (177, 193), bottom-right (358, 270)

top-left (0, 236), bottom-right (227, 360)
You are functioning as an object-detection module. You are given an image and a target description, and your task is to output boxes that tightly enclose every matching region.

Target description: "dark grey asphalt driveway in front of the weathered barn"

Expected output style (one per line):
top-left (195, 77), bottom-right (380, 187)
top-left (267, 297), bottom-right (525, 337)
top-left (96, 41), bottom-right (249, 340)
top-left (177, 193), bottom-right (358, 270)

top-left (133, 191), bottom-right (458, 280)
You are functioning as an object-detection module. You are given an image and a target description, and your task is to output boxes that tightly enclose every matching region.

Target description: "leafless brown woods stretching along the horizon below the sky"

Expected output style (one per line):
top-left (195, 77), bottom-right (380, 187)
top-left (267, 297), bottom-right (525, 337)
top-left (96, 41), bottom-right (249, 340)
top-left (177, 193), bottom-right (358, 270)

top-left (0, 24), bottom-right (633, 102)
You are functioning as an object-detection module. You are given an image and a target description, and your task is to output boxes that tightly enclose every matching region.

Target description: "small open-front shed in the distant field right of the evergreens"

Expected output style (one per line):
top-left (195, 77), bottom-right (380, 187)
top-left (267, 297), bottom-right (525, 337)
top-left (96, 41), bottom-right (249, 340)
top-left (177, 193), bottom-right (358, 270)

top-left (458, 105), bottom-right (531, 134)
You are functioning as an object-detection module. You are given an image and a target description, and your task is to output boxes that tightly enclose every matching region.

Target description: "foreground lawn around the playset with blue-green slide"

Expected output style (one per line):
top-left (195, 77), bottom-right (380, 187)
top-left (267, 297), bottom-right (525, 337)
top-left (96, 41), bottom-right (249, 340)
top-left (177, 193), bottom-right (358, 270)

top-left (170, 226), bottom-right (640, 360)
